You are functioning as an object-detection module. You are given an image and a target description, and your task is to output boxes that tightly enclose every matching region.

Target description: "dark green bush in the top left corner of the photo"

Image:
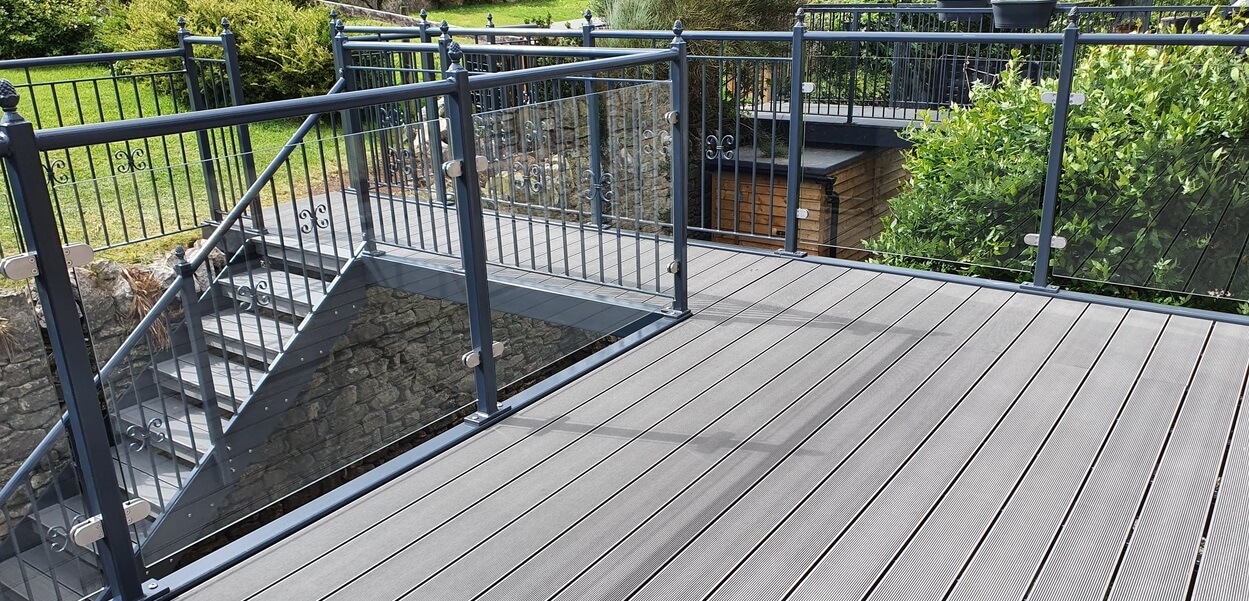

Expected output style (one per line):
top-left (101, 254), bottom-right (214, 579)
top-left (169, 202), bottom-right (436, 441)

top-left (0, 0), bottom-right (100, 60)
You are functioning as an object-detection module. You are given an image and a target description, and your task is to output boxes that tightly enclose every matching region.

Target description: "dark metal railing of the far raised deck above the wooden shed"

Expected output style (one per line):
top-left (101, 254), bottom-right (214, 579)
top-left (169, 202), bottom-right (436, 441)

top-left (803, 4), bottom-right (1212, 116)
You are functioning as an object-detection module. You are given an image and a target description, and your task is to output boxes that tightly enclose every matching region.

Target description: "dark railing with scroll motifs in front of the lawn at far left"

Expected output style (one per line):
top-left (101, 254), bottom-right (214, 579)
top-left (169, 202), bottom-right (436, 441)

top-left (0, 21), bottom-right (256, 256)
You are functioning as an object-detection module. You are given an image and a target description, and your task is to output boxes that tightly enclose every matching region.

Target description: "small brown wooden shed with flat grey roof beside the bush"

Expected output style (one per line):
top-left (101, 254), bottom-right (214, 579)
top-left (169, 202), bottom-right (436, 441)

top-left (706, 147), bottom-right (907, 260)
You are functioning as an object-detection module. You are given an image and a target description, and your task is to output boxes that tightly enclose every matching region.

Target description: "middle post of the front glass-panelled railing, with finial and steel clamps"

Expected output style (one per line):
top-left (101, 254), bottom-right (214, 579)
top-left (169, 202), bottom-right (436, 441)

top-left (442, 41), bottom-right (498, 425)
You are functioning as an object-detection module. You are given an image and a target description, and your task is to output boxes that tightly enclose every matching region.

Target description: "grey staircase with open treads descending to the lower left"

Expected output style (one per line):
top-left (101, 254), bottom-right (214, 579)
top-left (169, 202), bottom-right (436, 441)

top-left (0, 236), bottom-right (346, 601)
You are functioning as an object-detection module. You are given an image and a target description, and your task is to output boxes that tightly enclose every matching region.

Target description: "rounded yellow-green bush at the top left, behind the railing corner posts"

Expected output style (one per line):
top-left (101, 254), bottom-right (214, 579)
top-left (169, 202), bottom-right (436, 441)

top-left (105, 0), bottom-right (333, 102)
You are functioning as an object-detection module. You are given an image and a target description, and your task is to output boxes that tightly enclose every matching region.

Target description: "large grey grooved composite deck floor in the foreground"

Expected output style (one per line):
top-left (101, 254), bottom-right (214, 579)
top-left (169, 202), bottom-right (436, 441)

top-left (182, 244), bottom-right (1249, 600)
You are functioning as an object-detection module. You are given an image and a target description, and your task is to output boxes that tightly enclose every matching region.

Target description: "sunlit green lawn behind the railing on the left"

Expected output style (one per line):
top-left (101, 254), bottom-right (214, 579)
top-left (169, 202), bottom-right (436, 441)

top-left (0, 65), bottom-right (341, 269)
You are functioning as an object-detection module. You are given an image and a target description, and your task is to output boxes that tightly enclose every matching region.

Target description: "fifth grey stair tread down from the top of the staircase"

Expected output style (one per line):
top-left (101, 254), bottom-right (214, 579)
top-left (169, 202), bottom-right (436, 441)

top-left (117, 397), bottom-right (227, 464)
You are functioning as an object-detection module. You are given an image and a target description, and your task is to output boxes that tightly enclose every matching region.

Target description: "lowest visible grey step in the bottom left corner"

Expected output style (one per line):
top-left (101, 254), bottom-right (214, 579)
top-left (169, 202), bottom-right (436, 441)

top-left (0, 547), bottom-right (104, 601)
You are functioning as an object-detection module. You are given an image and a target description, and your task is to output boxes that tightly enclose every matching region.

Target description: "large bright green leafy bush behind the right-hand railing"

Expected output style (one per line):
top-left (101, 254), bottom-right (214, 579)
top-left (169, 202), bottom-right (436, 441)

top-left (868, 9), bottom-right (1249, 299)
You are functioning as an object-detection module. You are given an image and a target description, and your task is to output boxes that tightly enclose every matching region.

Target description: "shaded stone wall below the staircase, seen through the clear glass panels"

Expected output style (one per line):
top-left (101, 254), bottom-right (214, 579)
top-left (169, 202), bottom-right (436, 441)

top-left (217, 281), bottom-right (601, 522)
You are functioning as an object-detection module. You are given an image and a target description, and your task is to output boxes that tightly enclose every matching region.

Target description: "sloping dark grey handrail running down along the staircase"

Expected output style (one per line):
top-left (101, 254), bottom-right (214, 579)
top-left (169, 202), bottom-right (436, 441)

top-left (0, 77), bottom-right (346, 506)
